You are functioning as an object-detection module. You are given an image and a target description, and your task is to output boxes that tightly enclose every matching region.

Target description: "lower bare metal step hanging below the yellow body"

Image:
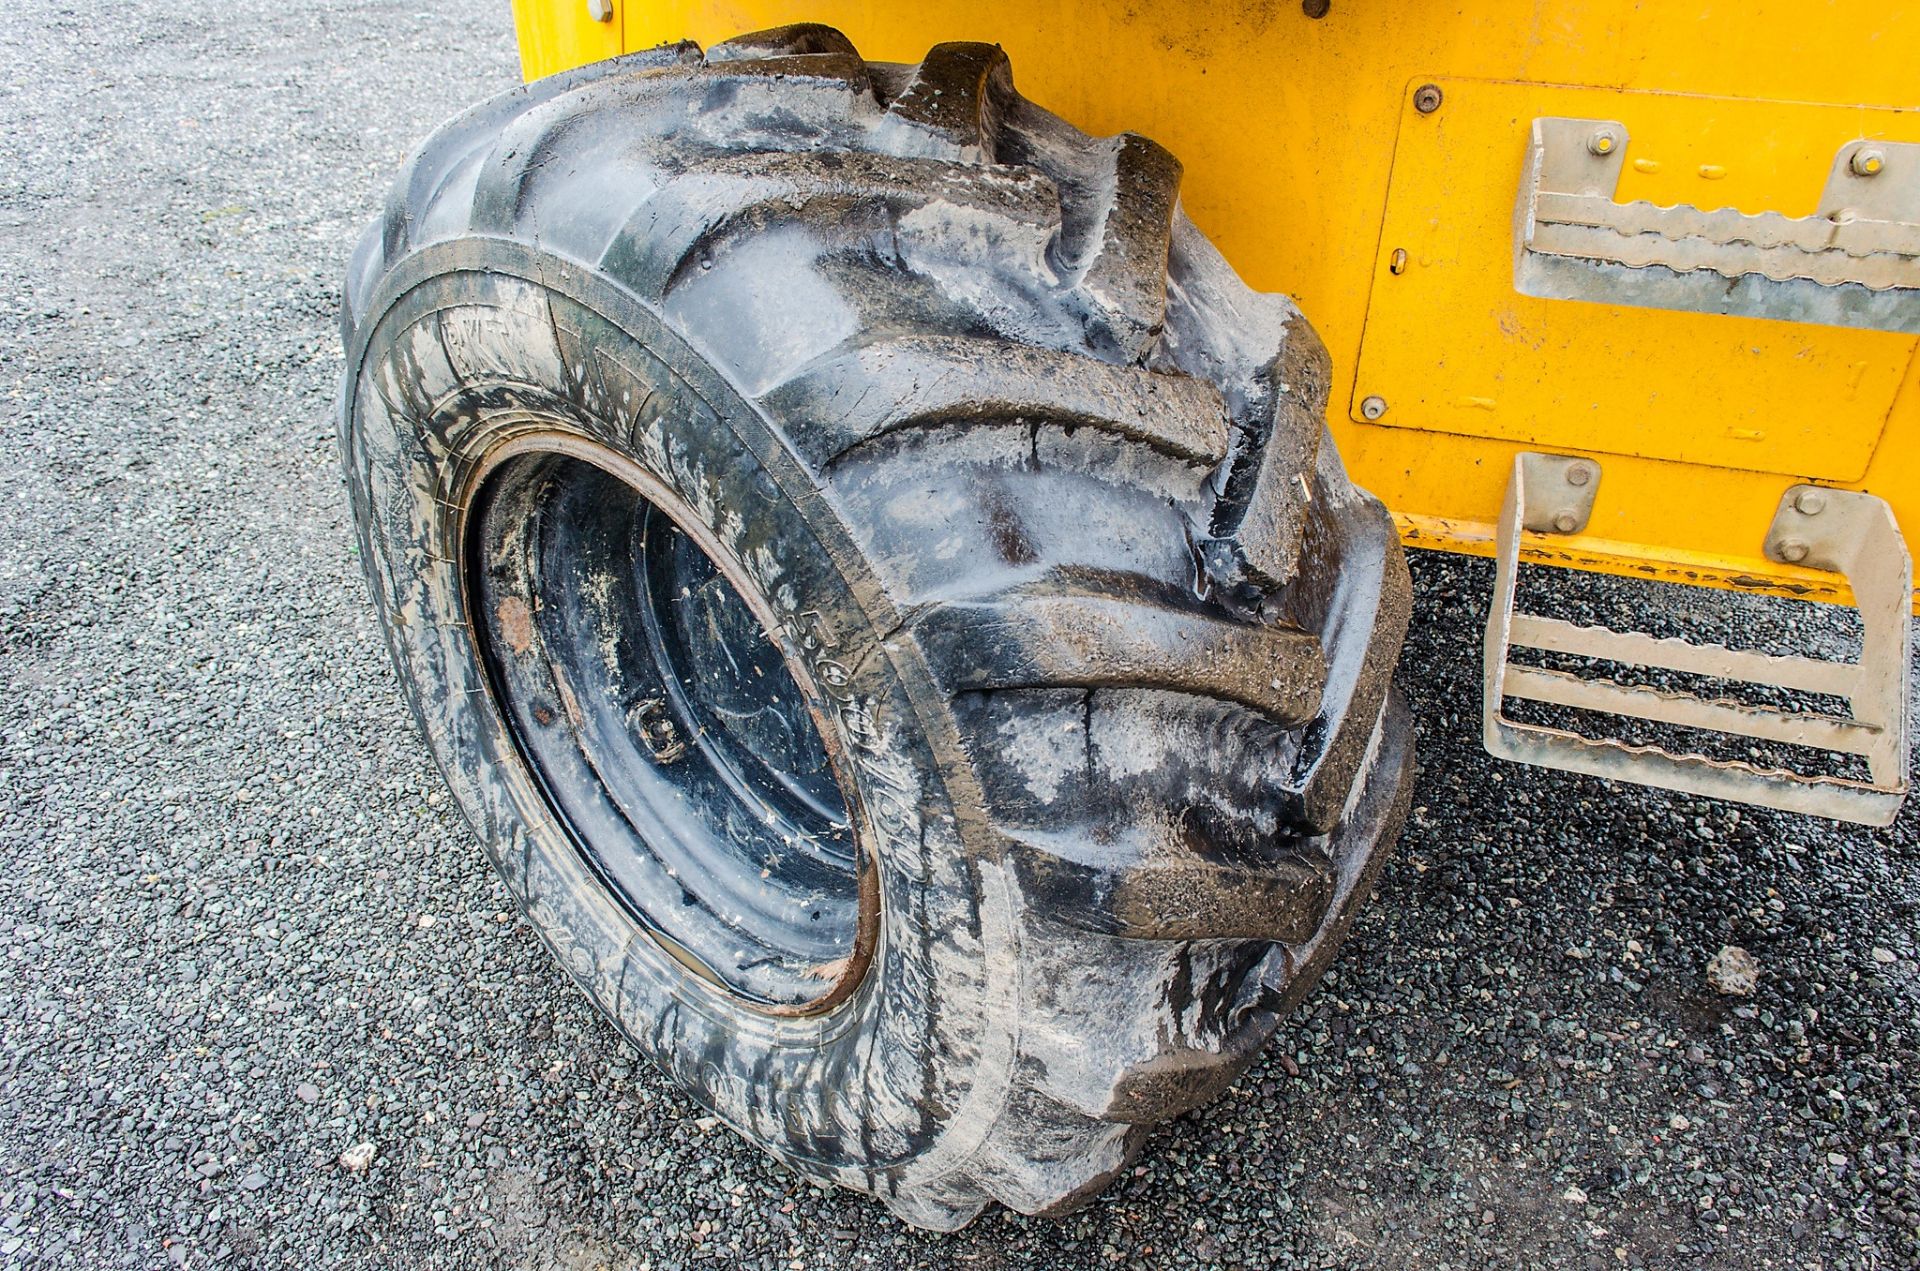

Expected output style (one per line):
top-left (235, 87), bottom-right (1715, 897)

top-left (1482, 453), bottom-right (1912, 826)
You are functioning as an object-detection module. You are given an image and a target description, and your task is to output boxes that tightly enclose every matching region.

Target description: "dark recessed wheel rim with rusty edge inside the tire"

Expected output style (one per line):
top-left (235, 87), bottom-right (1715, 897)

top-left (468, 444), bottom-right (862, 1012)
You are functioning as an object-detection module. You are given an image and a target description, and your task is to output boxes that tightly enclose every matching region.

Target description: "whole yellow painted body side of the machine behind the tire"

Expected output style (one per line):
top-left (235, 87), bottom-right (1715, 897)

top-left (515, 0), bottom-right (1920, 614)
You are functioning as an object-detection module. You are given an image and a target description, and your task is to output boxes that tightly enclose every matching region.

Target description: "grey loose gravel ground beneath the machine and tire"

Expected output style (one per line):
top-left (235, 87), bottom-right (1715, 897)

top-left (0, 0), bottom-right (1920, 1269)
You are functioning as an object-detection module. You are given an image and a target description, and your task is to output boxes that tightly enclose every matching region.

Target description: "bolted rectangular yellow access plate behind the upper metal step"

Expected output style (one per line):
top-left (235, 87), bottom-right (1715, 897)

top-left (1350, 79), bottom-right (1920, 480)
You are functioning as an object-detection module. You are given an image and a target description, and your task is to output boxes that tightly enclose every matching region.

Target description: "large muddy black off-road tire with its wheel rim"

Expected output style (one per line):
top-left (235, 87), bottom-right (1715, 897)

top-left (342, 27), bottom-right (1411, 1229)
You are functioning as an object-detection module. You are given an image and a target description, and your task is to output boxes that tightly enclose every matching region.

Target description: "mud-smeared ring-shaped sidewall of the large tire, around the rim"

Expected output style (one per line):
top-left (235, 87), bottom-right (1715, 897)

top-left (342, 238), bottom-right (1018, 1190)
